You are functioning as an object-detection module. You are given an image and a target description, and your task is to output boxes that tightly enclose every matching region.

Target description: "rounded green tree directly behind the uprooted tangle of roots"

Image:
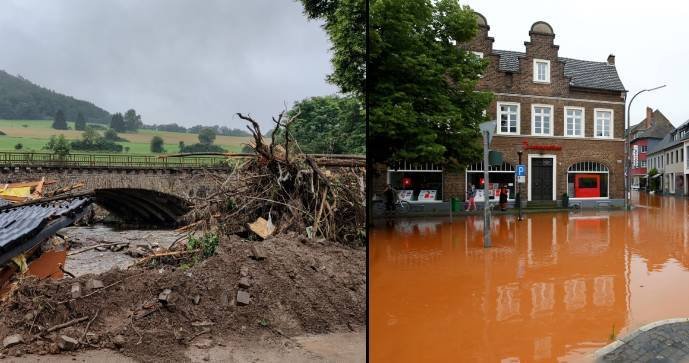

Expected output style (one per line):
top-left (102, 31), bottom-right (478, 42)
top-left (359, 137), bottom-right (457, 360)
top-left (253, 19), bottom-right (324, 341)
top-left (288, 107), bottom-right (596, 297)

top-left (275, 96), bottom-right (366, 154)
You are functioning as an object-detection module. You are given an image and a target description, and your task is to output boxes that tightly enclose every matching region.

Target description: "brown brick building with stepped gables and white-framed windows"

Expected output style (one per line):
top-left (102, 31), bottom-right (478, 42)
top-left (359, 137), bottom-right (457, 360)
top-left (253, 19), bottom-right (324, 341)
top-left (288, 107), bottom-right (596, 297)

top-left (374, 14), bottom-right (626, 206)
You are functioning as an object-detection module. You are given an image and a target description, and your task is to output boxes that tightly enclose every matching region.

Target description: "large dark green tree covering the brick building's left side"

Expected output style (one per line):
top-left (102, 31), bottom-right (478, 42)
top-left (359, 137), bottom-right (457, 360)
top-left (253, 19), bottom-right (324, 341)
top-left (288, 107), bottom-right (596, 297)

top-left (368, 0), bottom-right (492, 169)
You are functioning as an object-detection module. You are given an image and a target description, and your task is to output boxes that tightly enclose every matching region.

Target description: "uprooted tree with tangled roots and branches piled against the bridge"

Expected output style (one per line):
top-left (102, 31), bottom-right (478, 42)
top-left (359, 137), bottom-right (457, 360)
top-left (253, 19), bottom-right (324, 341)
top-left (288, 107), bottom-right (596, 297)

top-left (181, 111), bottom-right (365, 245)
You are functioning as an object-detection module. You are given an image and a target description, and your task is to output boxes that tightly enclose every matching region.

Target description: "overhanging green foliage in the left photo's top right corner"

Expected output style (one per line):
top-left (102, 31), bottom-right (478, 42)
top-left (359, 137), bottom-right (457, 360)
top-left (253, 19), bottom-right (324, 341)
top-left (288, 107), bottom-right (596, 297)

top-left (301, 0), bottom-right (366, 96)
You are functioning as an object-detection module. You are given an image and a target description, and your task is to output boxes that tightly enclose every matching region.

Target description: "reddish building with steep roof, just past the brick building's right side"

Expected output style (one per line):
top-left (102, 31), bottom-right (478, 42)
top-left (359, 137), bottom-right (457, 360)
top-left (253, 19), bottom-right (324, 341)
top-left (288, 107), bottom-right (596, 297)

top-left (629, 107), bottom-right (675, 190)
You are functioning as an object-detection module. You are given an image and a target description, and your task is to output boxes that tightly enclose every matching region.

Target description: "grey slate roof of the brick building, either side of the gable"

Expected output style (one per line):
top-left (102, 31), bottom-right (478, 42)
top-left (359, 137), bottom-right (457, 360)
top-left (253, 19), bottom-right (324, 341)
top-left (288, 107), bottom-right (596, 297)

top-left (493, 49), bottom-right (626, 91)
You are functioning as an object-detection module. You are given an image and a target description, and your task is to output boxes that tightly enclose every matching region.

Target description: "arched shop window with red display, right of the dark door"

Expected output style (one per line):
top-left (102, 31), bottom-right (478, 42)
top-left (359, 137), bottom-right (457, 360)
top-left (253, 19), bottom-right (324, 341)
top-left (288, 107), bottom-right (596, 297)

top-left (567, 161), bottom-right (609, 198)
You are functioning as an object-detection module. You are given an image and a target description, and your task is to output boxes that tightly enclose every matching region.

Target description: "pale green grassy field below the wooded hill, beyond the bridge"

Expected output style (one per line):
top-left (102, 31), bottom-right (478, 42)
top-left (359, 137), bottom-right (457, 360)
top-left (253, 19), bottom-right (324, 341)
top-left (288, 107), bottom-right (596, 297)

top-left (0, 120), bottom-right (249, 154)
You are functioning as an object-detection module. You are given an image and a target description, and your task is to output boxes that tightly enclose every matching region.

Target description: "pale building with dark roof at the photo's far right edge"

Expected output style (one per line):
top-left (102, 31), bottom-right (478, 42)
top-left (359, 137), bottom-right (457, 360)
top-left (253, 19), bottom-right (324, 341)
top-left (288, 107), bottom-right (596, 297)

top-left (647, 121), bottom-right (689, 196)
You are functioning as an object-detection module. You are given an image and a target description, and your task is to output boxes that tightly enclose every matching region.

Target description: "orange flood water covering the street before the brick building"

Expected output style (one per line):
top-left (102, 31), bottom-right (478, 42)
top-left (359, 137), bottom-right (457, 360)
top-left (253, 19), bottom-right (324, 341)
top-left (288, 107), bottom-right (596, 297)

top-left (369, 194), bottom-right (689, 362)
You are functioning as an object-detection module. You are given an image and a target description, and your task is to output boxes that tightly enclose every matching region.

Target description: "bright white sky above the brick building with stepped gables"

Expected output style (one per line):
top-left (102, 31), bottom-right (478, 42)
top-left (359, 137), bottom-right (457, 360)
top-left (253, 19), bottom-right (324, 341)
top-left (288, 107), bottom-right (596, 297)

top-left (460, 0), bottom-right (689, 126)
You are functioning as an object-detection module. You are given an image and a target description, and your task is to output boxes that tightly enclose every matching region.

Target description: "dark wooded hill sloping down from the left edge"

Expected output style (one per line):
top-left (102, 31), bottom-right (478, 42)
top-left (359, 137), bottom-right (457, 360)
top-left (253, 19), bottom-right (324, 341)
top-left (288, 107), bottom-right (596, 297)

top-left (0, 70), bottom-right (110, 123)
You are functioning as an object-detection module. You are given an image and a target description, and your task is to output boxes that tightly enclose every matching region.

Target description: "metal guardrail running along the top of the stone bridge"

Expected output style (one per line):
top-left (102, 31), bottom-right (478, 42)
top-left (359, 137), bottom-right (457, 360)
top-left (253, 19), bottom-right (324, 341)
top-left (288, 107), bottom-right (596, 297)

top-left (0, 152), bottom-right (229, 169)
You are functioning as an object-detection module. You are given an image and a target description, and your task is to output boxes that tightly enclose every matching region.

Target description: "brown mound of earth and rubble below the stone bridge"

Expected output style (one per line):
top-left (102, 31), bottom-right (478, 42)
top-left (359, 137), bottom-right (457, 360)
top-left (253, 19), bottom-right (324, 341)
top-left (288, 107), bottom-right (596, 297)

top-left (0, 233), bottom-right (366, 361)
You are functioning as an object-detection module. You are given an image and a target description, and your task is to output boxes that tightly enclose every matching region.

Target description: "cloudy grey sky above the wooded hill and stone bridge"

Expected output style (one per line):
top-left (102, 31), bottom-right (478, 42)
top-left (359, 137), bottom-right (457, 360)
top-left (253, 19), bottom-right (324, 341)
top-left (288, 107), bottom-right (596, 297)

top-left (0, 0), bottom-right (337, 128)
